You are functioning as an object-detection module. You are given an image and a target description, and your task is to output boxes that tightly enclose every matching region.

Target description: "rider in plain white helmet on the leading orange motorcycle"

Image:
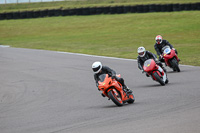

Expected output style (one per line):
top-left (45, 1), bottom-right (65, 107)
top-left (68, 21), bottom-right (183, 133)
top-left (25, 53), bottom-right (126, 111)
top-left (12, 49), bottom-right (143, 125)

top-left (92, 61), bottom-right (132, 93)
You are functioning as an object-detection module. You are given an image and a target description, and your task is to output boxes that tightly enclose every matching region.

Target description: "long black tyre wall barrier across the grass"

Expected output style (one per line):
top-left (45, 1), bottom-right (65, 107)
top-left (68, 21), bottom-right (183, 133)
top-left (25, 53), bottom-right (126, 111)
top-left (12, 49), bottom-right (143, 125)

top-left (0, 3), bottom-right (200, 20)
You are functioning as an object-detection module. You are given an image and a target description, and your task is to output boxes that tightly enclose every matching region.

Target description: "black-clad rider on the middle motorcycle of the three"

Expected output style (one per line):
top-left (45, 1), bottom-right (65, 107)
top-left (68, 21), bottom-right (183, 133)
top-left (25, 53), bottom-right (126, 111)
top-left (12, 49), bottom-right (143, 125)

top-left (137, 47), bottom-right (166, 77)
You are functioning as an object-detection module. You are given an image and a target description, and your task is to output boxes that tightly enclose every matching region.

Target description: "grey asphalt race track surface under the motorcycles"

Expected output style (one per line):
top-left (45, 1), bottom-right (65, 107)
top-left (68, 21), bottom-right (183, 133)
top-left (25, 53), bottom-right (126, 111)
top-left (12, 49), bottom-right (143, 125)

top-left (0, 47), bottom-right (200, 133)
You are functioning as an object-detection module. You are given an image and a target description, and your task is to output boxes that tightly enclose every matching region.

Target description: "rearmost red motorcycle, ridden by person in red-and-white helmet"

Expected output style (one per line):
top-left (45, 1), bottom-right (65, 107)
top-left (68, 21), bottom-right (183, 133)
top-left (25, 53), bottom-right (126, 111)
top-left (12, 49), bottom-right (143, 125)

top-left (162, 46), bottom-right (180, 72)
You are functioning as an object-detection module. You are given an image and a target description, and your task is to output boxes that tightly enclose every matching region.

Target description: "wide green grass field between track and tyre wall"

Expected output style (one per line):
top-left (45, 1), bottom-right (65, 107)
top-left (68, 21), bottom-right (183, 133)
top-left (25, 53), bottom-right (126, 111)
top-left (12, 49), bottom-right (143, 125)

top-left (0, 11), bottom-right (200, 66)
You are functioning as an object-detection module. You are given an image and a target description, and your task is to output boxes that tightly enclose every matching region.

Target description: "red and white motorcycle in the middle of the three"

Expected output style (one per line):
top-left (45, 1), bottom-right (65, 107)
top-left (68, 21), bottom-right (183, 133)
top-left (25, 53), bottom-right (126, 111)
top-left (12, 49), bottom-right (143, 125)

top-left (143, 59), bottom-right (168, 85)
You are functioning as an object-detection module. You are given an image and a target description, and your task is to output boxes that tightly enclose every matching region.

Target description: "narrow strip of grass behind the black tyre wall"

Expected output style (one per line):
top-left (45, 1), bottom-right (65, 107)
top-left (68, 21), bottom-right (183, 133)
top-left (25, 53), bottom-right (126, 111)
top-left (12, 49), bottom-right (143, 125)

top-left (0, 0), bottom-right (200, 13)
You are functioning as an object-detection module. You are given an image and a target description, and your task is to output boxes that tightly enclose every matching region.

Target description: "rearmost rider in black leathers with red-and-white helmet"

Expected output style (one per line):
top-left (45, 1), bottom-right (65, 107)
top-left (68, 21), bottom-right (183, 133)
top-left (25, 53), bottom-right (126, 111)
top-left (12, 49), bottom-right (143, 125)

top-left (154, 35), bottom-right (180, 62)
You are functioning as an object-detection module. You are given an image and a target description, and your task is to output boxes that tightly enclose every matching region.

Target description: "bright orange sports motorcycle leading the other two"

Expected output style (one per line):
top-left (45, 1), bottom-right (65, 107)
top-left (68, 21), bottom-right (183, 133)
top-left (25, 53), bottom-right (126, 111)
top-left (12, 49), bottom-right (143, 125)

top-left (98, 74), bottom-right (135, 106)
